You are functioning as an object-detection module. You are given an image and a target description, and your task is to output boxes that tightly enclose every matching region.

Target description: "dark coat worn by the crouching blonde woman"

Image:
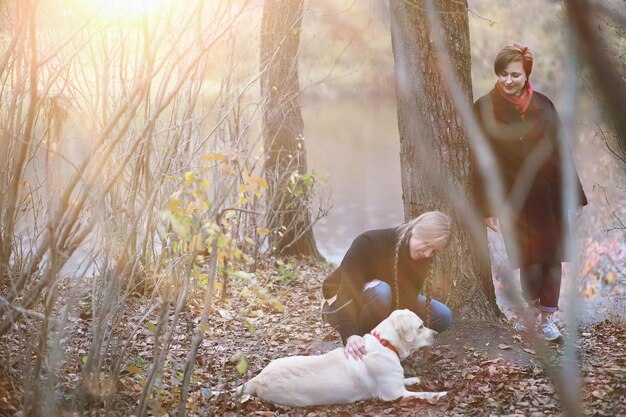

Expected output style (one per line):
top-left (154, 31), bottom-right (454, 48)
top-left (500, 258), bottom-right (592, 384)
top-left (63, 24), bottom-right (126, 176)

top-left (322, 228), bottom-right (432, 340)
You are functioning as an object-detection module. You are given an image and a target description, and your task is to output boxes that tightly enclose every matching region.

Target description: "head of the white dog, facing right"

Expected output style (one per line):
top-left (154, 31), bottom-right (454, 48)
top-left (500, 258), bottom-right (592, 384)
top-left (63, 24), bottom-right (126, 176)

top-left (372, 309), bottom-right (437, 359)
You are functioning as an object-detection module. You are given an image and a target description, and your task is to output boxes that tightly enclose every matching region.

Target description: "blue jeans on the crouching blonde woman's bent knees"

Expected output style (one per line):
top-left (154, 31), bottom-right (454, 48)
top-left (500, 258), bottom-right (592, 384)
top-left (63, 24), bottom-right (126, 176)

top-left (359, 281), bottom-right (452, 334)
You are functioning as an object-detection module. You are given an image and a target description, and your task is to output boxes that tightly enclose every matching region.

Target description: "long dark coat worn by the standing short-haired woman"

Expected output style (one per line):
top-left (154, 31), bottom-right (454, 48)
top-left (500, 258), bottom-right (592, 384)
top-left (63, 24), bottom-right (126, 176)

top-left (474, 88), bottom-right (587, 268)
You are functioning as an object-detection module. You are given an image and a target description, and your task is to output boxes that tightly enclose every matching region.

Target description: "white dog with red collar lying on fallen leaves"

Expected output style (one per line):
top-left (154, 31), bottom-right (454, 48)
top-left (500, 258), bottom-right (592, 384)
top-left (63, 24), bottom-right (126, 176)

top-left (229, 310), bottom-right (446, 406)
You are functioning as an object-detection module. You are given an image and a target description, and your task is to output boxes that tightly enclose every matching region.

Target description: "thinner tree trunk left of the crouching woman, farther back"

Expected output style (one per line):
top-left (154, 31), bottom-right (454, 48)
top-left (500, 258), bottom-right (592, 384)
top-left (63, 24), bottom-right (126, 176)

top-left (261, 0), bottom-right (320, 257)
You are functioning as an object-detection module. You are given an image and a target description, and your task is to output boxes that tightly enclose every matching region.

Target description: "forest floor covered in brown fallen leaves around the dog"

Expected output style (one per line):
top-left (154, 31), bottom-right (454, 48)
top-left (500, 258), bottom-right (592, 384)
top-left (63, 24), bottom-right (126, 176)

top-left (0, 255), bottom-right (626, 417)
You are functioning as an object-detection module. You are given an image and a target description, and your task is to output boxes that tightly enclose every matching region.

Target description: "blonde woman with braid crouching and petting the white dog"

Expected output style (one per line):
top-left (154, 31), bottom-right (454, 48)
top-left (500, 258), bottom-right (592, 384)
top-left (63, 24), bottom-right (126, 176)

top-left (322, 211), bottom-right (452, 359)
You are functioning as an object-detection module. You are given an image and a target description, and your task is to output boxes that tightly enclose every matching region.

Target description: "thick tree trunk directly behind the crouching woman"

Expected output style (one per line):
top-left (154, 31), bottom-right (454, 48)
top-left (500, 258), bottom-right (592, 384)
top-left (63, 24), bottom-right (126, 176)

top-left (389, 0), bottom-right (499, 319)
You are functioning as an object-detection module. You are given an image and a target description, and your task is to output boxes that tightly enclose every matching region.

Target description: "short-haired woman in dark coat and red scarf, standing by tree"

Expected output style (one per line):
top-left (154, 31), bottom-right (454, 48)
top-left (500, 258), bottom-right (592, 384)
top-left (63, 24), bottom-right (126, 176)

top-left (474, 44), bottom-right (587, 341)
